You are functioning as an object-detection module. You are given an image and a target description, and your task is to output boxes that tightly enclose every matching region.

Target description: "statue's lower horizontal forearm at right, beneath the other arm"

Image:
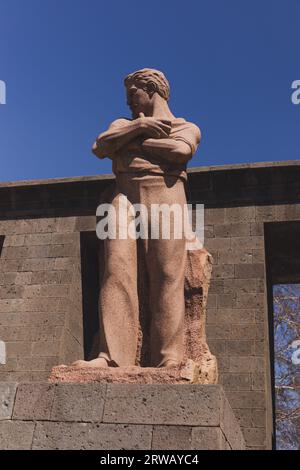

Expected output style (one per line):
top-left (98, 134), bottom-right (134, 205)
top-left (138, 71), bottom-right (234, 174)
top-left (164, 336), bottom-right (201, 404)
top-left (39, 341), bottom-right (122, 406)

top-left (142, 139), bottom-right (192, 164)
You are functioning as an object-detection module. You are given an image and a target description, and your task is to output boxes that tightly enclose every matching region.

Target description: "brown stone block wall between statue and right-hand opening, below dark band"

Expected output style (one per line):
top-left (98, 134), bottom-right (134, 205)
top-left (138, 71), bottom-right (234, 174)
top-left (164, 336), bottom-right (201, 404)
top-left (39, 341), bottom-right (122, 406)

top-left (206, 206), bottom-right (274, 448)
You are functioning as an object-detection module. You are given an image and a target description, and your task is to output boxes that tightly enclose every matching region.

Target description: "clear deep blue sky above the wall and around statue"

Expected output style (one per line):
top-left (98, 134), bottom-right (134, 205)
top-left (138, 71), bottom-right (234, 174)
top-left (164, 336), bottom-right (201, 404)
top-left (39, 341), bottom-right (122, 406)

top-left (0, 0), bottom-right (300, 181)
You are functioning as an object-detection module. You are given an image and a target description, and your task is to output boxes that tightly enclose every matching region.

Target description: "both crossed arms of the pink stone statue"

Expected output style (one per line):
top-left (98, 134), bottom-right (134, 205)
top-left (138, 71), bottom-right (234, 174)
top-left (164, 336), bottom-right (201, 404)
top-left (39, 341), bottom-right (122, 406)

top-left (92, 116), bottom-right (199, 164)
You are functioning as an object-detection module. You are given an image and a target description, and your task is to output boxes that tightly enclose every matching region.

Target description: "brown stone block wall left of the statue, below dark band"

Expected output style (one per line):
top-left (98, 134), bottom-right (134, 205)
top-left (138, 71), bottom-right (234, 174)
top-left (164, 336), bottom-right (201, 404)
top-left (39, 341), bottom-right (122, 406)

top-left (0, 218), bottom-right (83, 381)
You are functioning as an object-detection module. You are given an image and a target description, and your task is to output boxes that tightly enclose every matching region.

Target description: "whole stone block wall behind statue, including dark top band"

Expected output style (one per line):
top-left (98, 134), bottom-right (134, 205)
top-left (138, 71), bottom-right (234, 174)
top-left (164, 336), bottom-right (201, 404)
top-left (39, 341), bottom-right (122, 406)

top-left (0, 162), bottom-right (300, 449)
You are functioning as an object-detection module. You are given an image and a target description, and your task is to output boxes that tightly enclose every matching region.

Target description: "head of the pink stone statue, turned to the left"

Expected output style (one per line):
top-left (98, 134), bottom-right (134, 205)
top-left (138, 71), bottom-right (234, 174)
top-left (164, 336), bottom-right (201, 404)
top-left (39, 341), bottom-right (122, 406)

top-left (124, 69), bottom-right (170, 118)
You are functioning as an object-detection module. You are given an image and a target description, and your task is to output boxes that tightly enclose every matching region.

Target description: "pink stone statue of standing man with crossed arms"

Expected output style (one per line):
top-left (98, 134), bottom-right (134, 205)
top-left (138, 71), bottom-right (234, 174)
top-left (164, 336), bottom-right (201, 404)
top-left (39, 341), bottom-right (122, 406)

top-left (73, 69), bottom-right (201, 368)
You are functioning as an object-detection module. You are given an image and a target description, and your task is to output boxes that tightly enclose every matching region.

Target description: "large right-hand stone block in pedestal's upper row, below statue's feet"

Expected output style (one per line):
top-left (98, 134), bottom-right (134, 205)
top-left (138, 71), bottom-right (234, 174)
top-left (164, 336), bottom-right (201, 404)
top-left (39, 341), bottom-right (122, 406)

top-left (103, 384), bottom-right (223, 426)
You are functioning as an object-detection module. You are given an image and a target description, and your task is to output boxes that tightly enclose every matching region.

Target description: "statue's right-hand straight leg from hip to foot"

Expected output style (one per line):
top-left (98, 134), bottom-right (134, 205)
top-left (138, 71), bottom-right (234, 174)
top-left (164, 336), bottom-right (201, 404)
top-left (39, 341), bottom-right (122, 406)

top-left (142, 178), bottom-right (186, 367)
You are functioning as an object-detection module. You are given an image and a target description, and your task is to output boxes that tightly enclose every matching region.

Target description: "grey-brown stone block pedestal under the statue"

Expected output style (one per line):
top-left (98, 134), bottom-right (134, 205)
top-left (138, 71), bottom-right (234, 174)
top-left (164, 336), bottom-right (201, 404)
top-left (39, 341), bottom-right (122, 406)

top-left (0, 382), bottom-right (244, 450)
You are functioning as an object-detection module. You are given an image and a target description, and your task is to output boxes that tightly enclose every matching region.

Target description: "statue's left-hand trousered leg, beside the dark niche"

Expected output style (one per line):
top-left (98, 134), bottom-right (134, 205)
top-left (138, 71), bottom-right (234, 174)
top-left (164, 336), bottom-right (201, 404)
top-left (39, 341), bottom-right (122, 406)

top-left (99, 192), bottom-right (139, 366)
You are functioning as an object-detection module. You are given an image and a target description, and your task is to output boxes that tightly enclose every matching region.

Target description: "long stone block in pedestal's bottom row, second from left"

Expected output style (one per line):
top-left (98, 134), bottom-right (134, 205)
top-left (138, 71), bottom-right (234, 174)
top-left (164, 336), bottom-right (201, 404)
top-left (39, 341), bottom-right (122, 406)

top-left (32, 422), bottom-right (152, 450)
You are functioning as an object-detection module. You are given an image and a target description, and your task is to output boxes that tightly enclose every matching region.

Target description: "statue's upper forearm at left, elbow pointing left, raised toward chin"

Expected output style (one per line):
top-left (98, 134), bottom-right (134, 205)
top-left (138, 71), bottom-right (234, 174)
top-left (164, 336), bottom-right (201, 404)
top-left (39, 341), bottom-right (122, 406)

top-left (92, 120), bottom-right (142, 158)
